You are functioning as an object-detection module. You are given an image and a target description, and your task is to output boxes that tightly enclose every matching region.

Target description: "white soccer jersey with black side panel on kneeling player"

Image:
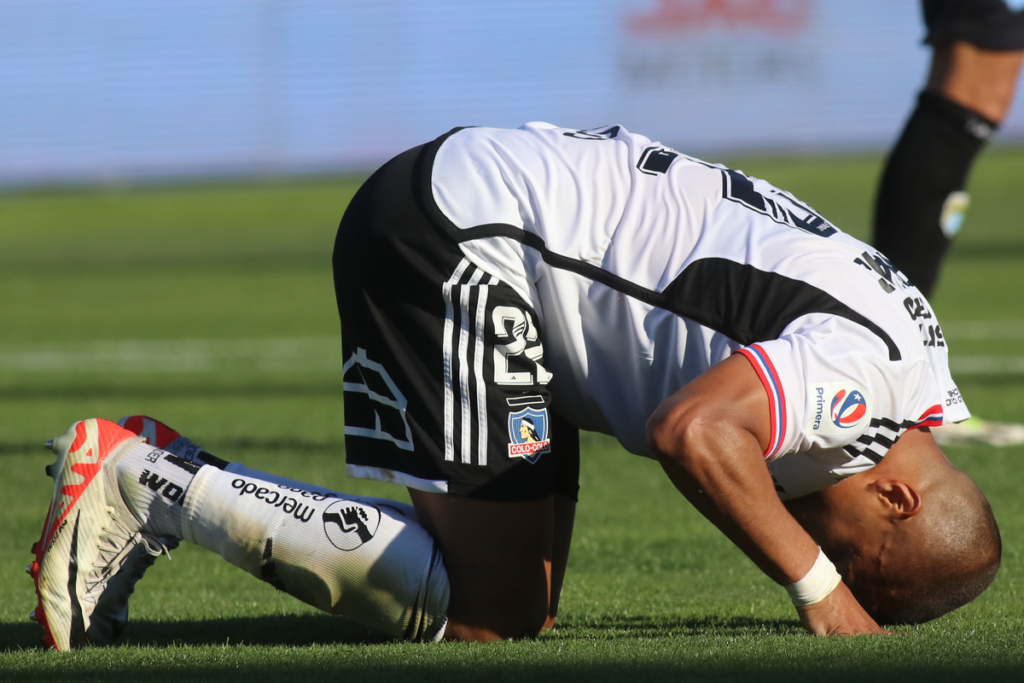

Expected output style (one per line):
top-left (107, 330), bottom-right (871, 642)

top-left (431, 123), bottom-right (969, 498)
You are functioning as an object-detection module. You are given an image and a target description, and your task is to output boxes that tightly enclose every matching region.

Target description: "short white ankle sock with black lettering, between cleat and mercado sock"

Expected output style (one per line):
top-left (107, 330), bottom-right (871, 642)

top-left (115, 442), bottom-right (200, 537)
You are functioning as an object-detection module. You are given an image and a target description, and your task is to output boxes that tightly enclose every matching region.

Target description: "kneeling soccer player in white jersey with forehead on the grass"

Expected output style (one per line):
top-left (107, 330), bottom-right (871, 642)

top-left (29, 124), bottom-right (1000, 647)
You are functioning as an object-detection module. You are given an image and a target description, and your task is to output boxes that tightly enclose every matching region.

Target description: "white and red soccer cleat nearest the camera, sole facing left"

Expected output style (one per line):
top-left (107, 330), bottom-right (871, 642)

top-left (29, 419), bottom-right (159, 650)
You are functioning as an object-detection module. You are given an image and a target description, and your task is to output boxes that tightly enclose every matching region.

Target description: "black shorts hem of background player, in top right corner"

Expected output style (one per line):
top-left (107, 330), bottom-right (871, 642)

top-left (922, 0), bottom-right (1024, 51)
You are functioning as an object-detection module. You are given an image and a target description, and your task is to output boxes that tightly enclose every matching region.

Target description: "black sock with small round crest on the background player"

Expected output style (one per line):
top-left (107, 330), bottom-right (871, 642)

top-left (873, 91), bottom-right (997, 296)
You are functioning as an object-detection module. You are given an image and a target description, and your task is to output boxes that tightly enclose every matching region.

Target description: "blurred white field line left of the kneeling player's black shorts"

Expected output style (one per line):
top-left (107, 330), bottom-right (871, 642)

top-left (0, 337), bottom-right (342, 374)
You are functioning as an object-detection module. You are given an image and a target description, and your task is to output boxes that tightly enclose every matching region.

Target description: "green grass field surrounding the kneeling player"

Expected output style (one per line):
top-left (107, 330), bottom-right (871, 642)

top-left (0, 150), bottom-right (1024, 683)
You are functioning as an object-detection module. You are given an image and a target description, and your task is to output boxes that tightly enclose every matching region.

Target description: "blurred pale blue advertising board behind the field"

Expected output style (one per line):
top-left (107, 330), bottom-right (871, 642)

top-left (6, 0), bottom-right (1024, 187)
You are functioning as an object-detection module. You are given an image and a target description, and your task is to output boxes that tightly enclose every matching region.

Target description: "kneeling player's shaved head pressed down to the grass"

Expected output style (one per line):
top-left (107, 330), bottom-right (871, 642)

top-left (787, 430), bottom-right (1002, 624)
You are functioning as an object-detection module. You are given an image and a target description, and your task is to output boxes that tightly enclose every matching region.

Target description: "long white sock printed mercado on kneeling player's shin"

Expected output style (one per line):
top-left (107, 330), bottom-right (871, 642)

top-left (180, 466), bottom-right (450, 640)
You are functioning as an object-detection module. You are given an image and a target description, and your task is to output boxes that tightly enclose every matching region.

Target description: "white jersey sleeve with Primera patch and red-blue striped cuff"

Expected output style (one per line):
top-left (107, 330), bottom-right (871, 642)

top-left (737, 317), bottom-right (966, 463)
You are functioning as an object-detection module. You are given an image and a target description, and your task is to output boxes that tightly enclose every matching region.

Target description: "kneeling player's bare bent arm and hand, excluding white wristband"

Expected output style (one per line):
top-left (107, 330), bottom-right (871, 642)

top-left (647, 355), bottom-right (884, 635)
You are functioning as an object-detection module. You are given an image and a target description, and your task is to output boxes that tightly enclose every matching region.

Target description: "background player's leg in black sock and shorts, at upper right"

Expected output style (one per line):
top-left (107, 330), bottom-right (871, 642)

top-left (873, 0), bottom-right (1024, 297)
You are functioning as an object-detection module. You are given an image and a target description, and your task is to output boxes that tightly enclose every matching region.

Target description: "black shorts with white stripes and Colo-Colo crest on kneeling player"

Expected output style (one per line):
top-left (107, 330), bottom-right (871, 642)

top-left (334, 132), bottom-right (580, 501)
